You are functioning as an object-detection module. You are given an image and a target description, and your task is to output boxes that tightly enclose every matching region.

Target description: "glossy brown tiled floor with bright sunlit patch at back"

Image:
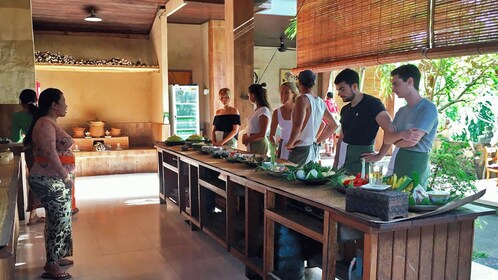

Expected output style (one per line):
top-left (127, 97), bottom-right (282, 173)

top-left (15, 174), bottom-right (246, 280)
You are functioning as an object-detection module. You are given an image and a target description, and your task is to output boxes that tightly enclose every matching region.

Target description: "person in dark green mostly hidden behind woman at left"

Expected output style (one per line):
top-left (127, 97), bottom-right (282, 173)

top-left (11, 89), bottom-right (45, 226)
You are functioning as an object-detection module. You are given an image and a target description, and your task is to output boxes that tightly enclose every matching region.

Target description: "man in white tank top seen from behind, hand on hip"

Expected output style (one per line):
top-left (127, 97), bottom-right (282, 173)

top-left (285, 70), bottom-right (338, 164)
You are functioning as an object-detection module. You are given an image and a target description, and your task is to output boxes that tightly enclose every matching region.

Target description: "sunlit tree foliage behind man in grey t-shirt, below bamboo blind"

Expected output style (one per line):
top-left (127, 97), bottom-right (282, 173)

top-left (376, 54), bottom-right (498, 142)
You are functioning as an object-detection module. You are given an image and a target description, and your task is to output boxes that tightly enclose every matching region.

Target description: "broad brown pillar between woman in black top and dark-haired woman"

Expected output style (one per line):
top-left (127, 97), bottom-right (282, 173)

top-left (225, 0), bottom-right (254, 149)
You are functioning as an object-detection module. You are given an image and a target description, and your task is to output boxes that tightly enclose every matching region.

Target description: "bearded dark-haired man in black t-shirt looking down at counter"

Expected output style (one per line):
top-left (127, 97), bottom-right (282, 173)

top-left (334, 69), bottom-right (392, 175)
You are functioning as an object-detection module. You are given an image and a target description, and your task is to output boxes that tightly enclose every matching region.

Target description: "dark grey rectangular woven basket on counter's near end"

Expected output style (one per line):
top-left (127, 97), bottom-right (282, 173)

top-left (346, 188), bottom-right (408, 221)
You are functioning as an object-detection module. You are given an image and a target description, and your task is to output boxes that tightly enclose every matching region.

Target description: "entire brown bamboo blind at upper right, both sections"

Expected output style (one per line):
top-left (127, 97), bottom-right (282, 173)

top-left (294, 0), bottom-right (498, 72)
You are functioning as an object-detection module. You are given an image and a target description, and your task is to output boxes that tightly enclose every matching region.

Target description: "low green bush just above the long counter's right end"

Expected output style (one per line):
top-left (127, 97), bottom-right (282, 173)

top-left (429, 137), bottom-right (477, 198)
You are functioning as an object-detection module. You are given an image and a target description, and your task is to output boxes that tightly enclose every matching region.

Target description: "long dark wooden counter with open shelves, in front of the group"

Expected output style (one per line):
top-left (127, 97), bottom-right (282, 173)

top-left (156, 142), bottom-right (494, 279)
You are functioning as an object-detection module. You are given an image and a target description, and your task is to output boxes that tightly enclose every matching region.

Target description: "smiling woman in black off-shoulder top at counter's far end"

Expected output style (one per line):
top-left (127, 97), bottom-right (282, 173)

top-left (211, 88), bottom-right (240, 149)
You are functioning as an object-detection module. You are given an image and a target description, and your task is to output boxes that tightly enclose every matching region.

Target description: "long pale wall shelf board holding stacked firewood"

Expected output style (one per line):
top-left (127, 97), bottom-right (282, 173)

top-left (35, 63), bottom-right (159, 73)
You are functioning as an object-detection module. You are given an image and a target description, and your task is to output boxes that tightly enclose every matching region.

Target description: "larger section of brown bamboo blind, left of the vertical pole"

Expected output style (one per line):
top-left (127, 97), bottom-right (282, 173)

top-left (297, 0), bottom-right (428, 68)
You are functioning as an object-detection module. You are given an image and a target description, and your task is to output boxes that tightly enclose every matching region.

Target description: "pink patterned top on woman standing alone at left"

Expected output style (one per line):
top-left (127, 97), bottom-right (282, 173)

top-left (30, 117), bottom-right (75, 179)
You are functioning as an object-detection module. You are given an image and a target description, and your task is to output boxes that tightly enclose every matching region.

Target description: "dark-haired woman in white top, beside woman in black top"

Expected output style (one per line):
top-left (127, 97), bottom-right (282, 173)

top-left (242, 83), bottom-right (271, 155)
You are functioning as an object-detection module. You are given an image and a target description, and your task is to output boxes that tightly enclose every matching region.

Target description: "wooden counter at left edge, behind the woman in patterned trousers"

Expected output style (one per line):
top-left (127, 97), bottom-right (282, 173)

top-left (0, 153), bottom-right (21, 280)
